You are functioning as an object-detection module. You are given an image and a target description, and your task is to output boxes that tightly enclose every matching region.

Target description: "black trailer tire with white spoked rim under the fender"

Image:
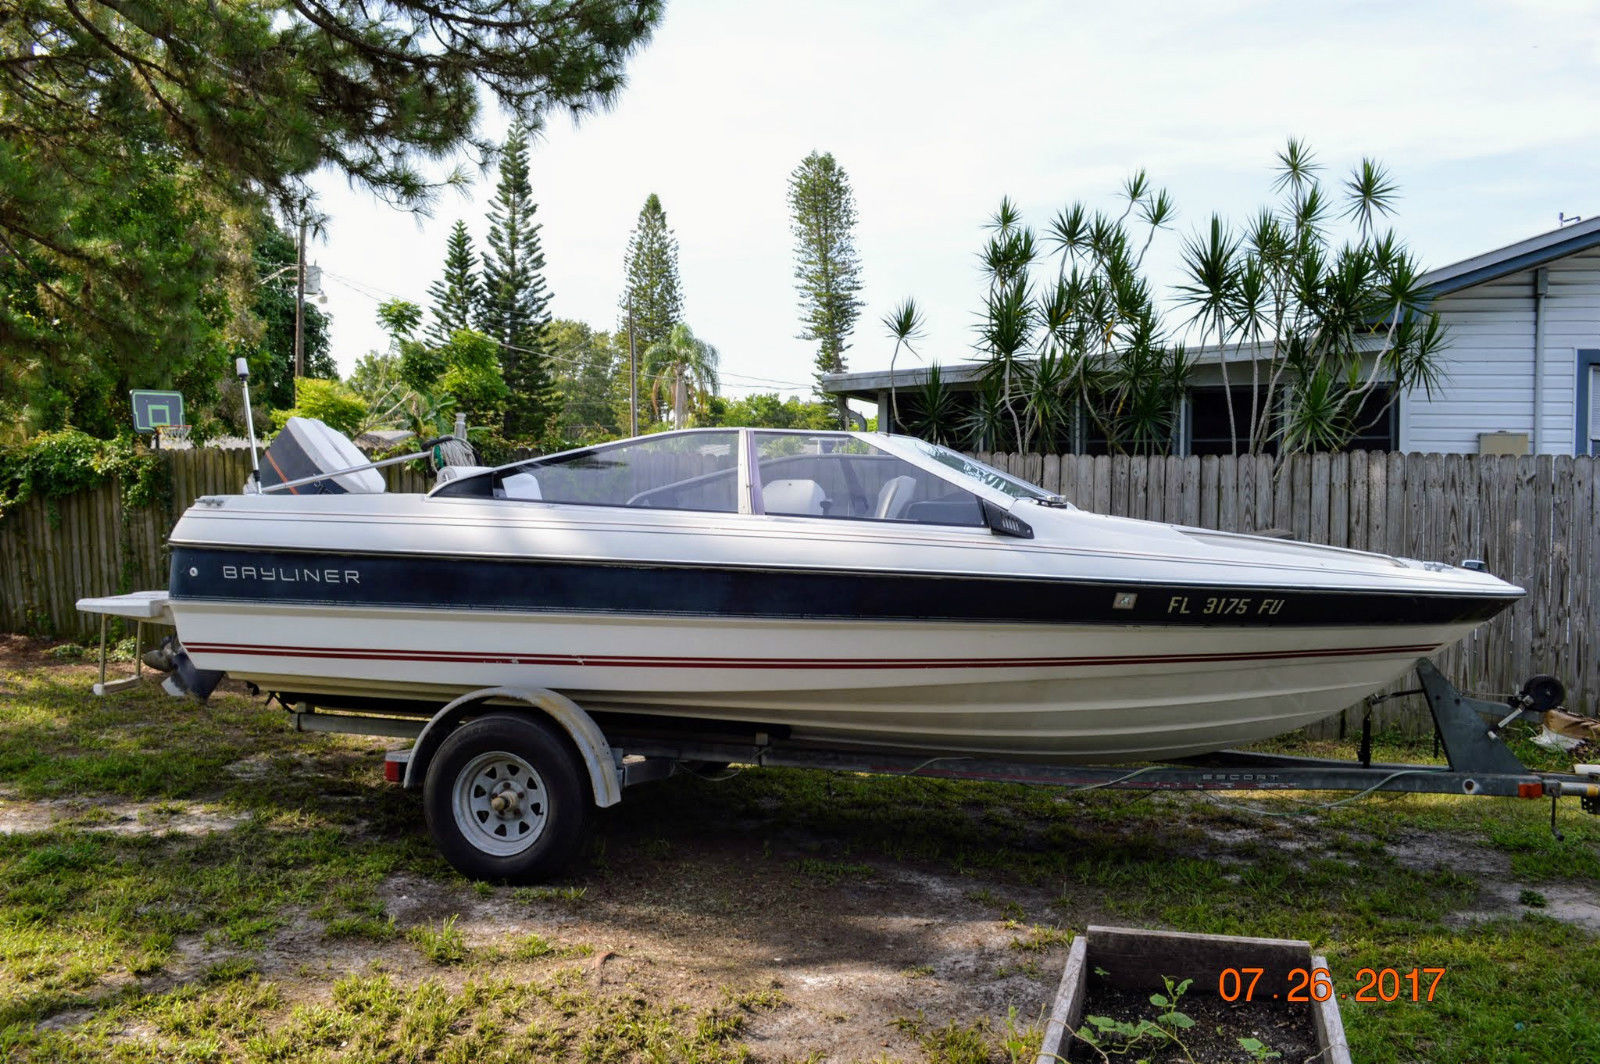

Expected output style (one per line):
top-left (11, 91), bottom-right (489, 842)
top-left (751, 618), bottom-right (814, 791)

top-left (422, 714), bottom-right (589, 880)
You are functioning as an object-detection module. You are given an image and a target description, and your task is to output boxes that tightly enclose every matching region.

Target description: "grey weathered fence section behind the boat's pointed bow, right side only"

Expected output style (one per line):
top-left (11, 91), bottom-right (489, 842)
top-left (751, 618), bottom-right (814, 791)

top-left (978, 451), bottom-right (1600, 731)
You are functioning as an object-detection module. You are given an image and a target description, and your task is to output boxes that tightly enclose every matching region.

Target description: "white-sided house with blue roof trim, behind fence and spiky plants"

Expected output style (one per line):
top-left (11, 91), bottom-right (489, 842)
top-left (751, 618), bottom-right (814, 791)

top-left (824, 218), bottom-right (1600, 454)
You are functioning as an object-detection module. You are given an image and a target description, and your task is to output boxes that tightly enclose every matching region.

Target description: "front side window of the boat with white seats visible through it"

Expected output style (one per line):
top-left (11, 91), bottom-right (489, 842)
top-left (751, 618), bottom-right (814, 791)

top-left (755, 432), bottom-right (984, 528)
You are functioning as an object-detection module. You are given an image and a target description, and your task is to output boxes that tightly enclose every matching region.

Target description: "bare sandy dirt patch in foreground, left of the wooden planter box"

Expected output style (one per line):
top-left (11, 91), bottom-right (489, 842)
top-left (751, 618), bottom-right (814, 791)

top-left (360, 845), bottom-right (1066, 1061)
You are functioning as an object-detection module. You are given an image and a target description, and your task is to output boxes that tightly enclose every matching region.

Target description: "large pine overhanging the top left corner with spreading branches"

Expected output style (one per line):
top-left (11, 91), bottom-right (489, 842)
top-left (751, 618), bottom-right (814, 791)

top-left (0, 0), bottom-right (662, 385)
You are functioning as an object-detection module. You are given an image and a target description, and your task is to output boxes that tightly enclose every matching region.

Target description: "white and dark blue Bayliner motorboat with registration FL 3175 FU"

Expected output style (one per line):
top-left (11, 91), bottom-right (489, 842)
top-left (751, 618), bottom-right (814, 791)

top-left (170, 422), bottom-right (1523, 763)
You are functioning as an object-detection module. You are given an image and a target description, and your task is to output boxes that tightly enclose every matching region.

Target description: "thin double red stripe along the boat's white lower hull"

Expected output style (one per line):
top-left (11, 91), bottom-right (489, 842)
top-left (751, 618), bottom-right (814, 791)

top-left (184, 643), bottom-right (1434, 669)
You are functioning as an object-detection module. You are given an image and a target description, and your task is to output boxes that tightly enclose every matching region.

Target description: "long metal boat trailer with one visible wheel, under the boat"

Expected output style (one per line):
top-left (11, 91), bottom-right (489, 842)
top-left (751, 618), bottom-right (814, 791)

top-left (68, 592), bottom-right (1600, 878)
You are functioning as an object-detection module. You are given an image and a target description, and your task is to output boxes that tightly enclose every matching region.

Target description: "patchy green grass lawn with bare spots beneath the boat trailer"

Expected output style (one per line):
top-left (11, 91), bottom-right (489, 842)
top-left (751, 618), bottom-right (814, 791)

top-left (0, 642), bottom-right (1600, 1064)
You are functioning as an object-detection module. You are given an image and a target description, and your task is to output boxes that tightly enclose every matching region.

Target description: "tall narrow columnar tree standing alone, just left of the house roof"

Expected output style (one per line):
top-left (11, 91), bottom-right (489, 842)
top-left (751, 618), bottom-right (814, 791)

top-left (789, 152), bottom-right (861, 424)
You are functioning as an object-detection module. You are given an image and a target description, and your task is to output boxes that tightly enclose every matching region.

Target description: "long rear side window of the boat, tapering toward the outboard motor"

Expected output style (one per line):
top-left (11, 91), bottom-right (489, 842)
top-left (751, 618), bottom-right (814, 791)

top-left (435, 432), bottom-right (739, 514)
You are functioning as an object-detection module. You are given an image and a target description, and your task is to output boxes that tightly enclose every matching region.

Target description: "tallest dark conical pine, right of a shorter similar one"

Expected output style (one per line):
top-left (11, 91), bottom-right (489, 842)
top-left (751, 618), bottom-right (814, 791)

top-left (480, 123), bottom-right (557, 440)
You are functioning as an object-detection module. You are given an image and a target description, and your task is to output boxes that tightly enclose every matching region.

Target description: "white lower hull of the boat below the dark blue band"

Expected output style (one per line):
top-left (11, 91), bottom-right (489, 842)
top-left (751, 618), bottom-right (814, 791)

top-left (174, 603), bottom-right (1472, 763)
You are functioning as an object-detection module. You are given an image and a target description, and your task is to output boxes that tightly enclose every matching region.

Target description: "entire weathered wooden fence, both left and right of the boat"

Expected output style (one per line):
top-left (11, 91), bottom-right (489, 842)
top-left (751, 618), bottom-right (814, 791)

top-left (0, 448), bottom-right (1600, 734)
